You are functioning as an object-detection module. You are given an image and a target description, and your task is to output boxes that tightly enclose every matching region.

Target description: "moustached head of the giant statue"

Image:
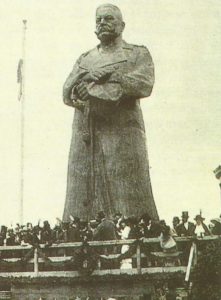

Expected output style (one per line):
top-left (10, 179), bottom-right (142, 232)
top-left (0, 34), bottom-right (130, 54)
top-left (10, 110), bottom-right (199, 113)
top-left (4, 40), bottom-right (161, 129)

top-left (95, 4), bottom-right (125, 42)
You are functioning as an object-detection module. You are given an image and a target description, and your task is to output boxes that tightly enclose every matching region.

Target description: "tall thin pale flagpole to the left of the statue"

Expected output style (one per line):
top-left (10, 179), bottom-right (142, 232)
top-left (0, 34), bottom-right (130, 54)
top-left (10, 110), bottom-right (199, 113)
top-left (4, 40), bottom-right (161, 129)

top-left (19, 20), bottom-right (27, 225)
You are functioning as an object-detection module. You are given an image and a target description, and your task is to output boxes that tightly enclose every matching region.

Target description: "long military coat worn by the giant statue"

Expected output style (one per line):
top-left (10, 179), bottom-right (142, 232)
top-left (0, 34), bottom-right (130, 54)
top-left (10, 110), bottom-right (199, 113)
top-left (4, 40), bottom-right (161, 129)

top-left (63, 41), bottom-right (158, 220)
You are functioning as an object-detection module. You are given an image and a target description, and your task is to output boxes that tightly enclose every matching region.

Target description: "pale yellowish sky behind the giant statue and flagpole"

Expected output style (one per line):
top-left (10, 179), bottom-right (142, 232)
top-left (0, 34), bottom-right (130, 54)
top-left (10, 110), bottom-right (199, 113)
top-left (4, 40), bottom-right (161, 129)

top-left (0, 0), bottom-right (221, 224)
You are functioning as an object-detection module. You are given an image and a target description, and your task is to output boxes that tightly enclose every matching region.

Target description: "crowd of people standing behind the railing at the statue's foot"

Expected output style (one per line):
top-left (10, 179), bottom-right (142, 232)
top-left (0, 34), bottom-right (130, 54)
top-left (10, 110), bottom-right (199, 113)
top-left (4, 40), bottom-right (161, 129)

top-left (0, 211), bottom-right (221, 246)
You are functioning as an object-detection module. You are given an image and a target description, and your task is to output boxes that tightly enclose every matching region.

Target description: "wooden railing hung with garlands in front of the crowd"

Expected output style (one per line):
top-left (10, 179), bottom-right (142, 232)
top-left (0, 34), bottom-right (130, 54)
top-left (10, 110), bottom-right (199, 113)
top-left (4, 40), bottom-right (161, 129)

top-left (0, 236), bottom-right (219, 281)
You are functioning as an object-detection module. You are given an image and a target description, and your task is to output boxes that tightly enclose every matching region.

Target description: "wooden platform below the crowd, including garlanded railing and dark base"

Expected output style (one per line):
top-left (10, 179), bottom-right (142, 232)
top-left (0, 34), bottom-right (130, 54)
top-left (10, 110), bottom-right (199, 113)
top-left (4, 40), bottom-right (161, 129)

top-left (0, 236), bottom-right (220, 300)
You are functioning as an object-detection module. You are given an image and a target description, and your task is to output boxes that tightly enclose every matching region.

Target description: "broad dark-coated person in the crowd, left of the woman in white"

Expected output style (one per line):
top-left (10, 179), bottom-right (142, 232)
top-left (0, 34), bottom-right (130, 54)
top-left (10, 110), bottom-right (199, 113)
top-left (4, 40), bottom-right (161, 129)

top-left (93, 211), bottom-right (117, 241)
